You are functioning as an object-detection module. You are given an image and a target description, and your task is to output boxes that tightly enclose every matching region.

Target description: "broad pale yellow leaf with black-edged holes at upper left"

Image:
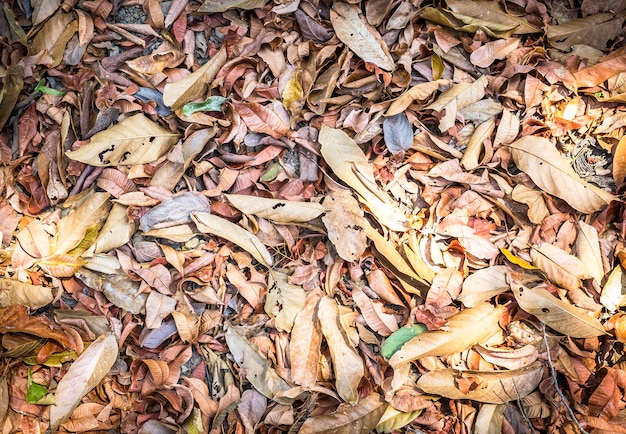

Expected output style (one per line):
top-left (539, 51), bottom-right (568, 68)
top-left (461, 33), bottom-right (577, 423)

top-left (65, 113), bottom-right (178, 166)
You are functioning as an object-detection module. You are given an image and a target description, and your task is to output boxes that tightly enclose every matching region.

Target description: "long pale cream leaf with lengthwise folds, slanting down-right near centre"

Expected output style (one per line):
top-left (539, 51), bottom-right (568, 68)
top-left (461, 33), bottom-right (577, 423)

top-left (318, 125), bottom-right (408, 232)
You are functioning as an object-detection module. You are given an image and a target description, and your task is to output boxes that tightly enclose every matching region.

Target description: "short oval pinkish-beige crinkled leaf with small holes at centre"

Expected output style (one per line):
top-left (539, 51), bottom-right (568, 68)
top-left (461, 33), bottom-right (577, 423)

top-left (322, 190), bottom-right (367, 262)
